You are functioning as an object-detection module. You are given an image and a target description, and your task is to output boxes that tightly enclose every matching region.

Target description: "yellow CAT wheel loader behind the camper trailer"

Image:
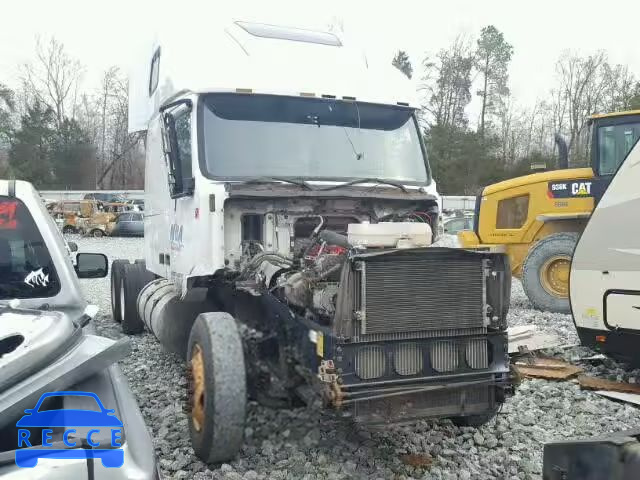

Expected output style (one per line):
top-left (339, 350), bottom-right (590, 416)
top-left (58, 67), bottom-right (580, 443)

top-left (458, 110), bottom-right (640, 313)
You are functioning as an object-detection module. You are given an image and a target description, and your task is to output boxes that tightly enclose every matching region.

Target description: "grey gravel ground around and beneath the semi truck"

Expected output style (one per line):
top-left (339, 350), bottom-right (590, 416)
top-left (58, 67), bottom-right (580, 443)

top-left (73, 238), bottom-right (640, 480)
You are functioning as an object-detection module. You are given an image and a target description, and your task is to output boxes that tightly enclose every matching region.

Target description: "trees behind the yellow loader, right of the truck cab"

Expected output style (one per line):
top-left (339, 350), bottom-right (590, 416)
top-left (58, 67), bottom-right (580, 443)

top-left (392, 25), bottom-right (640, 195)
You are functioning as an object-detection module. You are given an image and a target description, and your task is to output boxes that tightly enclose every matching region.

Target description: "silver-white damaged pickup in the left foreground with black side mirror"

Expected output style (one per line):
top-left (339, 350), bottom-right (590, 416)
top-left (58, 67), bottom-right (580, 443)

top-left (0, 180), bottom-right (159, 480)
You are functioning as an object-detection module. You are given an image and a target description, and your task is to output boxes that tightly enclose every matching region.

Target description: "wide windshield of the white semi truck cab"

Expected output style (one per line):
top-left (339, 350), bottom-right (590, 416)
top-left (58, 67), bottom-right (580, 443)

top-left (200, 94), bottom-right (430, 185)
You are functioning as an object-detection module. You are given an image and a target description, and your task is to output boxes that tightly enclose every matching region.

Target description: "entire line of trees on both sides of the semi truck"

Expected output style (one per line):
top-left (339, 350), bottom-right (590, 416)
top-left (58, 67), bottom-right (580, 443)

top-left (0, 30), bottom-right (640, 195)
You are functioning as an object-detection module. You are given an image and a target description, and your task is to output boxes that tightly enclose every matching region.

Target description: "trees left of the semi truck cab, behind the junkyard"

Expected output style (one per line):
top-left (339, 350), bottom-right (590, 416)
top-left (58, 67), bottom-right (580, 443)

top-left (0, 38), bottom-right (144, 189)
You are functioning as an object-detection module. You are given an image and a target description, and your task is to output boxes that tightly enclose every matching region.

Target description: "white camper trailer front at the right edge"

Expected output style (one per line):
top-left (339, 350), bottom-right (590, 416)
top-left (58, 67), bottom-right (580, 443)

top-left (570, 139), bottom-right (640, 364)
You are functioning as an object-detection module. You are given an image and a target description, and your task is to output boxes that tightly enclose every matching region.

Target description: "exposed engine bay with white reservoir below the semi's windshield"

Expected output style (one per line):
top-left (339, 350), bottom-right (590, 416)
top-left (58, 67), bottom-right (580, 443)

top-left (225, 198), bottom-right (438, 325)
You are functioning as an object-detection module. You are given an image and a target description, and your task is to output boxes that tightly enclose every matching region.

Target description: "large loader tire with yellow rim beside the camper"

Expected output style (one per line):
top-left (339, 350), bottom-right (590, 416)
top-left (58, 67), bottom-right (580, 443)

top-left (522, 232), bottom-right (578, 313)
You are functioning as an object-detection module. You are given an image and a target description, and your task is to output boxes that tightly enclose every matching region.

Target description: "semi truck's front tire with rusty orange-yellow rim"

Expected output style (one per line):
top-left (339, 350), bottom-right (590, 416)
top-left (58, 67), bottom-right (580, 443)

top-left (187, 312), bottom-right (247, 463)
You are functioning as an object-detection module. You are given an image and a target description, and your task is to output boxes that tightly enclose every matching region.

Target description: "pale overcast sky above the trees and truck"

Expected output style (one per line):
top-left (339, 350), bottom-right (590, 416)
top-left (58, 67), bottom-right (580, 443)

top-left (0, 0), bottom-right (640, 124)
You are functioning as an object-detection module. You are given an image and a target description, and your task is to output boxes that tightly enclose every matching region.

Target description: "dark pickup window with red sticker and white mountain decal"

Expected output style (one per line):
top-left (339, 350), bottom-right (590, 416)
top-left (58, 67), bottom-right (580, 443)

top-left (0, 196), bottom-right (60, 300)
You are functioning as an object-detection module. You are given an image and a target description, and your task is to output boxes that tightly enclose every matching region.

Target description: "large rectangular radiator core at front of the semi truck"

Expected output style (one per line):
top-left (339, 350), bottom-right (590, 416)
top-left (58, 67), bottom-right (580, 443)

top-left (356, 253), bottom-right (485, 335)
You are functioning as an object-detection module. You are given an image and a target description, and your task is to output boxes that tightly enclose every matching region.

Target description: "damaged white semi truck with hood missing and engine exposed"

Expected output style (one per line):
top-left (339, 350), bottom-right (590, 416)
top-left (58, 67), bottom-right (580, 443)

top-left (112, 17), bottom-right (510, 462)
